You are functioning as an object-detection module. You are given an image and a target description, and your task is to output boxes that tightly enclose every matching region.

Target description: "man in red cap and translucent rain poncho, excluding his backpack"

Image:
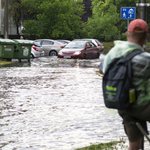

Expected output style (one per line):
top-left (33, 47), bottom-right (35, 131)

top-left (99, 19), bottom-right (150, 150)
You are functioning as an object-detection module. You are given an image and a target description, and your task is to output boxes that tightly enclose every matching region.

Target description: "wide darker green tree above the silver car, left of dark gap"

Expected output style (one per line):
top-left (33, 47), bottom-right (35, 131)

top-left (22, 0), bottom-right (85, 39)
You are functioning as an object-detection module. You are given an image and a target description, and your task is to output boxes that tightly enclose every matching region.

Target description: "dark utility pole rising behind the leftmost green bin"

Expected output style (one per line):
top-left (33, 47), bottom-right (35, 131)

top-left (4, 0), bottom-right (8, 39)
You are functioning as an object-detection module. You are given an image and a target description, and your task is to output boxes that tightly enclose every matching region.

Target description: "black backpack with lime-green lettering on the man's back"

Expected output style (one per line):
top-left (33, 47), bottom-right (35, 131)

top-left (103, 50), bottom-right (143, 109)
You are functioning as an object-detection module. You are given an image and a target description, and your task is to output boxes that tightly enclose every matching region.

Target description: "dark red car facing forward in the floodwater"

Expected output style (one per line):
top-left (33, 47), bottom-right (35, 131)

top-left (58, 41), bottom-right (100, 59)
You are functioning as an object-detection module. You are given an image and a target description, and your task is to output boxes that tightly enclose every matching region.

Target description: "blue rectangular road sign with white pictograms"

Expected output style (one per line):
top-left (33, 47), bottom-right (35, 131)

top-left (121, 7), bottom-right (136, 19)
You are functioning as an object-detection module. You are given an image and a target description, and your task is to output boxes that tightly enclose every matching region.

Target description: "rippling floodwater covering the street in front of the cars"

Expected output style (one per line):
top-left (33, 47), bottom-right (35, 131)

top-left (0, 57), bottom-right (150, 150)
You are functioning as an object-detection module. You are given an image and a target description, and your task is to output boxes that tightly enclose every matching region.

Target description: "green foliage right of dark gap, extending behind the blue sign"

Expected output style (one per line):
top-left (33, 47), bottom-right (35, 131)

top-left (84, 0), bottom-right (144, 41)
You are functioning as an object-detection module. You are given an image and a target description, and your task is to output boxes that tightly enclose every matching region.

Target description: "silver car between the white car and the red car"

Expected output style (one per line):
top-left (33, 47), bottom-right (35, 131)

top-left (35, 39), bottom-right (66, 56)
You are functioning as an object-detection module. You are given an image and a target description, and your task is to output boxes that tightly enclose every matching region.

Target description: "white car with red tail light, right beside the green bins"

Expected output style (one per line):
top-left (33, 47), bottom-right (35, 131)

top-left (31, 42), bottom-right (44, 58)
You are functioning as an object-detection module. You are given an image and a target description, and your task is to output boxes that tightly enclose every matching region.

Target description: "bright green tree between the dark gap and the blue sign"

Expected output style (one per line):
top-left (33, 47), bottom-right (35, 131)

top-left (84, 0), bottom-right (119, 40)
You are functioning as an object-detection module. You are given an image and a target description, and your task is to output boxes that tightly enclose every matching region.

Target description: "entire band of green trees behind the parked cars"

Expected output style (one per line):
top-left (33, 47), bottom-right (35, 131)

top-left (2, 0), bottom-right (150, 41)
